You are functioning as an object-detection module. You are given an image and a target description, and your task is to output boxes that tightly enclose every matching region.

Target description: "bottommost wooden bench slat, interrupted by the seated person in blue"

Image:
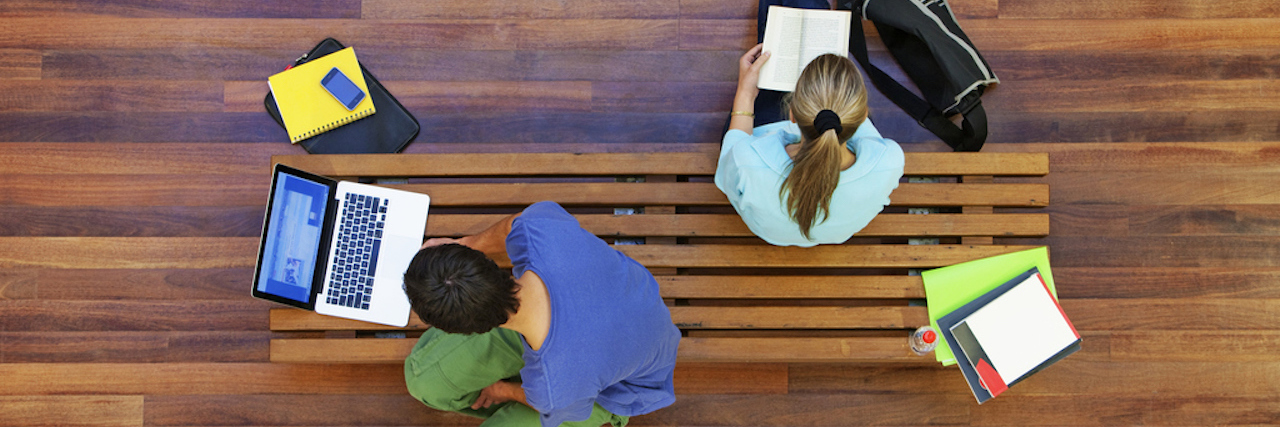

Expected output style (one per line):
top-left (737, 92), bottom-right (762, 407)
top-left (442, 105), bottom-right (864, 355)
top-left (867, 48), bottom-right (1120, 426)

top-left (270, 336), bottom-right (937, 364)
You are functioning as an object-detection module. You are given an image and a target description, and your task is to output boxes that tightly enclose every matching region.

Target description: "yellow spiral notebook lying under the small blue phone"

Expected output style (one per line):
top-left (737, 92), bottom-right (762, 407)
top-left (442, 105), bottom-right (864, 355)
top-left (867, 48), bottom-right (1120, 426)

top-left (266, 47), bottom-right (376, 143)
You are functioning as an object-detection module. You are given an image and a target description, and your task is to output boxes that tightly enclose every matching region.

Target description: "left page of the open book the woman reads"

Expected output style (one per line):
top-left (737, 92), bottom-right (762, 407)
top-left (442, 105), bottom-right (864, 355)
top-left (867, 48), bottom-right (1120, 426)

top-left (756, 6), bottom-right (804, 92)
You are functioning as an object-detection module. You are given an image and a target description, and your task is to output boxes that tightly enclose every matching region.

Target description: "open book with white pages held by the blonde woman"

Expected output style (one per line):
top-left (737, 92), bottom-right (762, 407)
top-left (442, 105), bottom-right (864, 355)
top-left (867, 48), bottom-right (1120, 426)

top-left (758, 6), bottom-right (852, 92)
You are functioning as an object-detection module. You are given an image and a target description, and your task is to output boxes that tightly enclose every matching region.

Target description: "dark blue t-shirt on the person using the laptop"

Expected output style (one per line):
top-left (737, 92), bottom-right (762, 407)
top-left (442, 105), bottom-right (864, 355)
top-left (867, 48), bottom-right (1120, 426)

top-left (507, 202), bottom-right (680, 427)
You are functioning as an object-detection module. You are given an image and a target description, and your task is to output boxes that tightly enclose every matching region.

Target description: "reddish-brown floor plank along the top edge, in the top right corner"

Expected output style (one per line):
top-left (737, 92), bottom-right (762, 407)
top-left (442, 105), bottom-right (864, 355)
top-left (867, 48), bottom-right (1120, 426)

top-left (1000, 0), bottom-right (1280, 19)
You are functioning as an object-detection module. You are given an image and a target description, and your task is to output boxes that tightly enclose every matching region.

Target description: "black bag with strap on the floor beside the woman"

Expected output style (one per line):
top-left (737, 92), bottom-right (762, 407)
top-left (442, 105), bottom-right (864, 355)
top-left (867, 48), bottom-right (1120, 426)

top-left (837, 0), bottom-right (1000, 151)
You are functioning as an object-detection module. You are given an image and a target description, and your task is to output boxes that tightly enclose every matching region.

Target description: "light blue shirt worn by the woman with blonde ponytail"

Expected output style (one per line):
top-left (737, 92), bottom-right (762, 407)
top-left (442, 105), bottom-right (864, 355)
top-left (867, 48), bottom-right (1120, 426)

top-left (716, 119), bottom-right (905, 247)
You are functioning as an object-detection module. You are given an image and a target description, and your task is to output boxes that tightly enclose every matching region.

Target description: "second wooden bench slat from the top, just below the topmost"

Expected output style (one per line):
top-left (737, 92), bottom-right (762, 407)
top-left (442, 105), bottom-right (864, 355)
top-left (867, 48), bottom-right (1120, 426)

top-left (387, 183), bottom-right (1048, 207)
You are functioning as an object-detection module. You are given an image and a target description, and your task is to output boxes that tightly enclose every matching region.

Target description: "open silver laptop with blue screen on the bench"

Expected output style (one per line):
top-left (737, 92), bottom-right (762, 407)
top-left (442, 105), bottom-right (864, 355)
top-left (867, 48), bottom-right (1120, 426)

top-left (253, 165), bottom-right (431, 326)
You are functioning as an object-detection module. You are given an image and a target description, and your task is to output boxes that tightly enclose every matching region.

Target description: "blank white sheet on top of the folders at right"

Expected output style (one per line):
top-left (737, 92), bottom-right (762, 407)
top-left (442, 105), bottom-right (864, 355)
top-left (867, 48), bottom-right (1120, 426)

top-left (965, 275), bottom-right (1079, 382)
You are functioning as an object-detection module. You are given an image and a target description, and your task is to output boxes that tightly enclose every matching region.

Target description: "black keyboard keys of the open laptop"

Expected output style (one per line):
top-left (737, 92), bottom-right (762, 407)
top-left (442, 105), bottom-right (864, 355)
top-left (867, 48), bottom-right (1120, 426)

top-left (325, 194), bottom-right (389, 309)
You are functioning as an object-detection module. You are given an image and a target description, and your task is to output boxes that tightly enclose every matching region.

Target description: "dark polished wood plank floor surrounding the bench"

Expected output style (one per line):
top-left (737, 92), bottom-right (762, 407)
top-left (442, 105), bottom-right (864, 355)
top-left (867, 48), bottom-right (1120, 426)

top-left (0, 0), bottom-right (1280, 426)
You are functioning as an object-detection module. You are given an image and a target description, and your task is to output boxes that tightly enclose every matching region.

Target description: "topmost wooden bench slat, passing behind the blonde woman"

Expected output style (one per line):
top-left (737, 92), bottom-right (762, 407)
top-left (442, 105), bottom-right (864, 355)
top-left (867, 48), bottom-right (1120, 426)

top-left (271, 151), bottom-right (1048, 178)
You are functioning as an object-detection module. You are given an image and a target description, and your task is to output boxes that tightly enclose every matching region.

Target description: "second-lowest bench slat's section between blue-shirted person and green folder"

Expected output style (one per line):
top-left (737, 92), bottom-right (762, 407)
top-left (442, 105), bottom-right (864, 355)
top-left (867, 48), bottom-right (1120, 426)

top-left (671, 307), bottom-right (929, 329)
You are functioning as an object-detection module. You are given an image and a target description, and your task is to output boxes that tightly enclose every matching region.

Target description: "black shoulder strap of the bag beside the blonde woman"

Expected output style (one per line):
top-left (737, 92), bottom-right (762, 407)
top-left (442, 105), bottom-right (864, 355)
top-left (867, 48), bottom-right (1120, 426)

top-left (849, 15), bottom-right (987, 151)
